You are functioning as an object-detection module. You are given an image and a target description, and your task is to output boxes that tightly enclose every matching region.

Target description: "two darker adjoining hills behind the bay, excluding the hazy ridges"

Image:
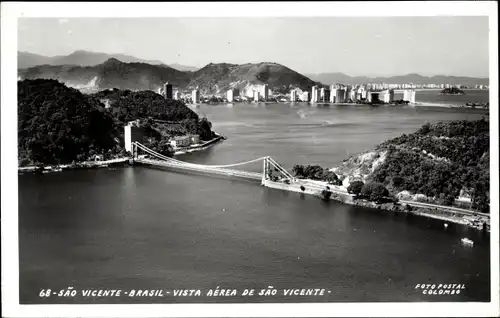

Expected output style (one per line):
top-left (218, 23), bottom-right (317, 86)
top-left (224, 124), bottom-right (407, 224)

top-left (18, 58), bottom-right (320, 93)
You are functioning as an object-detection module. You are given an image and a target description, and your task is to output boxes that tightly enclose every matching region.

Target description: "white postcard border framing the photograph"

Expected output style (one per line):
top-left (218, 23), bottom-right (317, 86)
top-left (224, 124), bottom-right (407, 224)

top-left (1, 1), bottom-right (500, 317)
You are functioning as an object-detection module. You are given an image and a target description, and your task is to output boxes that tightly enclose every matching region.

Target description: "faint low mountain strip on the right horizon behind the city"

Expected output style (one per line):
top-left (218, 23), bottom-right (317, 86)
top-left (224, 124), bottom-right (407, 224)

top-left (307, 73), bottom-right (489, 85)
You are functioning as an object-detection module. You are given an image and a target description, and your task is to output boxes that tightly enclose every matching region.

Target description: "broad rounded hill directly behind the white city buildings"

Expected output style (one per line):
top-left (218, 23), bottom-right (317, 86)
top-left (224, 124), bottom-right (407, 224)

top-left (188, 63), bottom-right (316, 93)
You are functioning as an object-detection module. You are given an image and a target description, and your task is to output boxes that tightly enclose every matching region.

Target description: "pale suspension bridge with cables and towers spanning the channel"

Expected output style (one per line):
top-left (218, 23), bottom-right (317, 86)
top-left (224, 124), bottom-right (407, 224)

top-left (132, 142), bottom-right (296, 184)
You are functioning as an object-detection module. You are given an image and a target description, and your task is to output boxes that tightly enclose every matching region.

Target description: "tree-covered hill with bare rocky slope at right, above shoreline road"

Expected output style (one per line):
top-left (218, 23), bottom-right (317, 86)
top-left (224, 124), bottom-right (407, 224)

top-left (336, 119), bottom-right (490, 212)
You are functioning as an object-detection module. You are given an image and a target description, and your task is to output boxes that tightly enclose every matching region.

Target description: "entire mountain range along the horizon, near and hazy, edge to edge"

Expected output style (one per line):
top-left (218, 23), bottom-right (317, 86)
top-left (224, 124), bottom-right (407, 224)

top-left (18, 50), bottom-right (489, 93)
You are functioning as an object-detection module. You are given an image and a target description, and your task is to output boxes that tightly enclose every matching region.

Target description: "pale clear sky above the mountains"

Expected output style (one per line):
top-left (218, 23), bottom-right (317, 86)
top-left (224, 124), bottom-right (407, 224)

top-left (18, 16), bottom-right (489, 77)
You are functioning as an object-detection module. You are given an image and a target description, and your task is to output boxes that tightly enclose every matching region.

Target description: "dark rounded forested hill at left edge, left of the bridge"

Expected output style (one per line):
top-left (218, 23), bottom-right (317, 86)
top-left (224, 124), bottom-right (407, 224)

top-left (17, 79), bottom-right (122, 164)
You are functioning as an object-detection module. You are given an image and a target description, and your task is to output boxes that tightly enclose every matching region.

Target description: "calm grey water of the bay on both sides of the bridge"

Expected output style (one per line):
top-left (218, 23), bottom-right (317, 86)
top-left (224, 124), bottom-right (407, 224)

top-left (19, 104), bottom-right (490, 303)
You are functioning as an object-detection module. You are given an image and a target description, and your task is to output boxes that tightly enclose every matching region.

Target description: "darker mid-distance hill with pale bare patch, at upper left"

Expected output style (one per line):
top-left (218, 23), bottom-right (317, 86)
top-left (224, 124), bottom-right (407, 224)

top-left (18, 58), bottom-right (190, 90)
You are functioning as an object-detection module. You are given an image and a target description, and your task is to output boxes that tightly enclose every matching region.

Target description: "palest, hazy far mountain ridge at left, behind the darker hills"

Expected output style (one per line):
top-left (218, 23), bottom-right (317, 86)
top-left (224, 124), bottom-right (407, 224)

top-left (17, 50), bottom-right (164, 69)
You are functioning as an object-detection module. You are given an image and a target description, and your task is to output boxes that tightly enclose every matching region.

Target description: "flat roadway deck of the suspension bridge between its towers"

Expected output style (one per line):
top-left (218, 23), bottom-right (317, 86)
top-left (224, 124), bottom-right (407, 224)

top-left (135, 159), bottom-right (262, 180)
